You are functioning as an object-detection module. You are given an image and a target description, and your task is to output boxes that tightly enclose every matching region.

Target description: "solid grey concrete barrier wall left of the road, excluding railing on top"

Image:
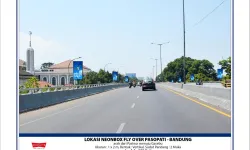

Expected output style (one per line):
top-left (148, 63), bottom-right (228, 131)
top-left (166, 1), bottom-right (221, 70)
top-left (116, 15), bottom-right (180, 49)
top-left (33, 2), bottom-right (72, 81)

top-left (19, 84), bottom-right (127, 113)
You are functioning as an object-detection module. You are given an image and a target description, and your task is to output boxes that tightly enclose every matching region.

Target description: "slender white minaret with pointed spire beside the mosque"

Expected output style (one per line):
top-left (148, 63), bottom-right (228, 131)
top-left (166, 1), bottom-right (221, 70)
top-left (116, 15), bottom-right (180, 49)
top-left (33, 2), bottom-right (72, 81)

top-left (26, 31), bottom-right (35, 74)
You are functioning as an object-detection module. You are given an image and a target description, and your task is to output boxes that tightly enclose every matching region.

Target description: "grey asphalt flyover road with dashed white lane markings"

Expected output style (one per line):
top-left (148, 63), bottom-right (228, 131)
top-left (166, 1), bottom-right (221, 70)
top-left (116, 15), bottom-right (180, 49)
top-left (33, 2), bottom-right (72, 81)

top-left (19, 86), bottom-right (231, 133)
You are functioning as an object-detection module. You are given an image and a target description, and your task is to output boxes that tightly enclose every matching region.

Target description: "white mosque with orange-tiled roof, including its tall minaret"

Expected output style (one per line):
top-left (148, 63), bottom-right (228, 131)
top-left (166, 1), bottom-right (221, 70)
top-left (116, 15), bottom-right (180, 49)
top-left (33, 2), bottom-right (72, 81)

top-left (19, 31), bottom-right (91, 86)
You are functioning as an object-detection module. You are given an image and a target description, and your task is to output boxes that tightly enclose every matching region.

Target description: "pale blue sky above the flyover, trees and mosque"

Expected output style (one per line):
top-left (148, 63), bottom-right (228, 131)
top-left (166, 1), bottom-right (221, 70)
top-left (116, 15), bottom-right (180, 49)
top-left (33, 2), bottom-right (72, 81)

top-left (19, 0), bottom-right (231, 77)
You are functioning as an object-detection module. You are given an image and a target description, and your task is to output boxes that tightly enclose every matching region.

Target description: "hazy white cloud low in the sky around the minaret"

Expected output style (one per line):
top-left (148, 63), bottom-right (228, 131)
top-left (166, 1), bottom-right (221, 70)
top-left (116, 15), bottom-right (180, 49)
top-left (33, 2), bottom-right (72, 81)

top-left (19, 32), bottom-right (70, 69)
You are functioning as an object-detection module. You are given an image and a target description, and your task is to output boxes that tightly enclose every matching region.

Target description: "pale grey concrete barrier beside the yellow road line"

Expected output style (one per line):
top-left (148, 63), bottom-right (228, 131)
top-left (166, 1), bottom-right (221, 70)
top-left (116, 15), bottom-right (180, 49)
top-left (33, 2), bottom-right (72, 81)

top-left (160, 83), bottom-right (231, 111)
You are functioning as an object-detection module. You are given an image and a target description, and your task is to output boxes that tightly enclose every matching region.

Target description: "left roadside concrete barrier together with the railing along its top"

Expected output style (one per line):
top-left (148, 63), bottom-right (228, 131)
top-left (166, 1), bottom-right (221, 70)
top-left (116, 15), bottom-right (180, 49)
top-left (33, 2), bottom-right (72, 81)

top-left (19, 83), bottom-right (128, 113)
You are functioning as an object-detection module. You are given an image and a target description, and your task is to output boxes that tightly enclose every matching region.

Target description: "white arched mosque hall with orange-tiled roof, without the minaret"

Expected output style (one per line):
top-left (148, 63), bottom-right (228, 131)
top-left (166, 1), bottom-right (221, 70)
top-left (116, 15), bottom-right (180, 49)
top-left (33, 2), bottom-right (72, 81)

top-left (35, 60), bottom-right (91, 86)
